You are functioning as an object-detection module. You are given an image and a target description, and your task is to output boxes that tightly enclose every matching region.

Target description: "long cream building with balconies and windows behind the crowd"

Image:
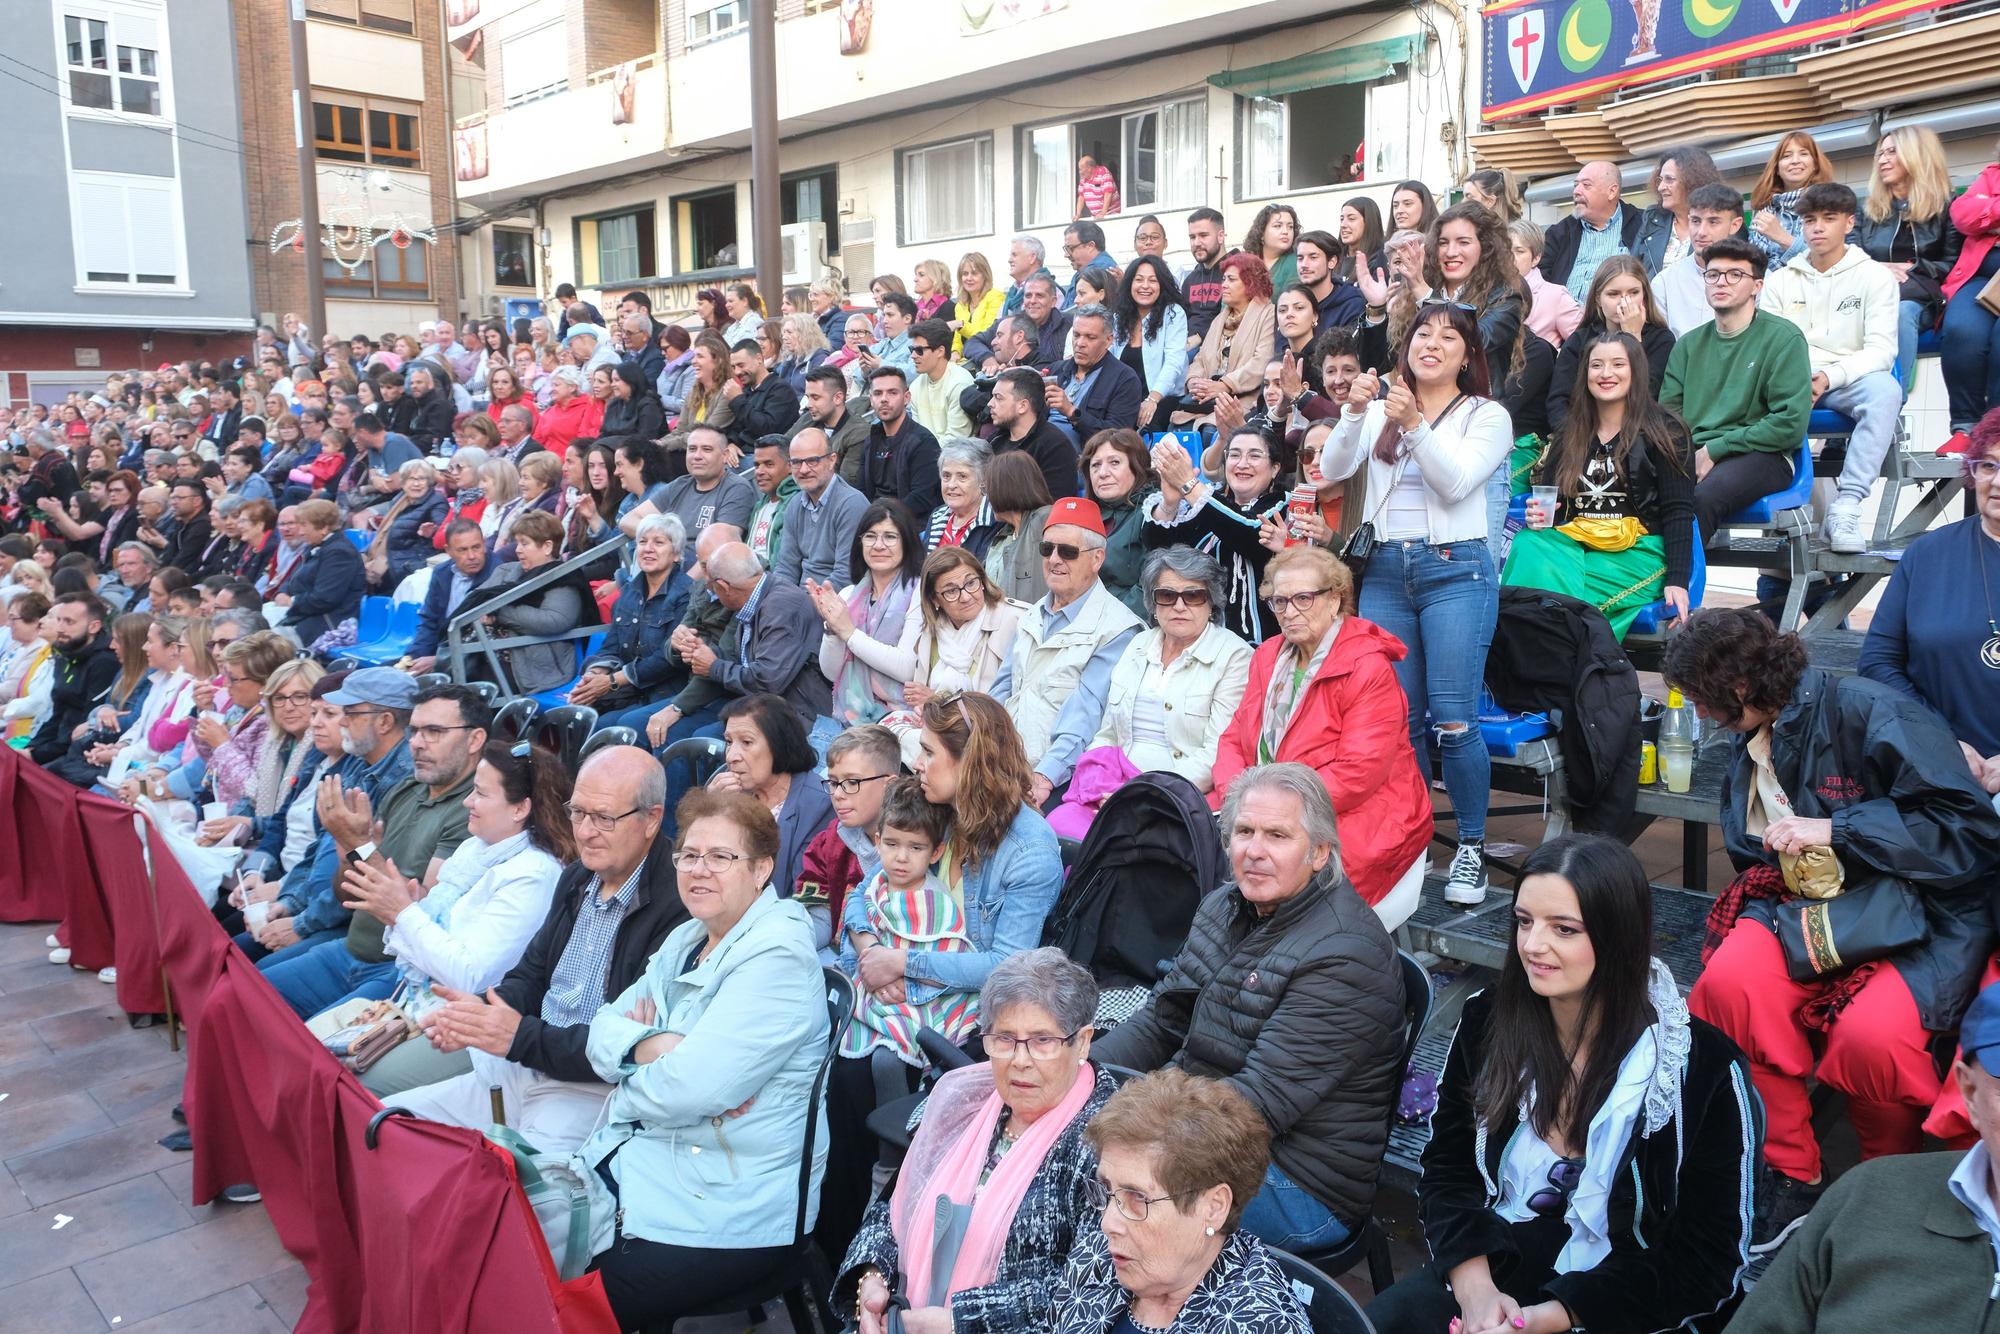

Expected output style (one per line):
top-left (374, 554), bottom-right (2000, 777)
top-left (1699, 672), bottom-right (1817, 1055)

top-left (448, 0), bottom-right (1478, 318)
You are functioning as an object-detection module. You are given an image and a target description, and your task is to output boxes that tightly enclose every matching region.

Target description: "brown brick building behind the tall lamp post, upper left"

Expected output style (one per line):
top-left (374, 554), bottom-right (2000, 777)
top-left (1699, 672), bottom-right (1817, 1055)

top-left (238, 0), bottom-right (460, 350)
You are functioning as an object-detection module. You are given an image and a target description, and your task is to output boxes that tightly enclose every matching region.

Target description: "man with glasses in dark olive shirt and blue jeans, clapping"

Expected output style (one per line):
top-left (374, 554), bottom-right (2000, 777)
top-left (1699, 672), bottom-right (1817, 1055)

top-left (264, 672), bottom-right (492, 1020)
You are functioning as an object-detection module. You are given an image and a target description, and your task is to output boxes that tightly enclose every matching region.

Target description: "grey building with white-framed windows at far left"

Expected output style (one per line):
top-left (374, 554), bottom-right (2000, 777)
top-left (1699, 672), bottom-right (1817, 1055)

top-left (0, 0), bottom-right (254, 402)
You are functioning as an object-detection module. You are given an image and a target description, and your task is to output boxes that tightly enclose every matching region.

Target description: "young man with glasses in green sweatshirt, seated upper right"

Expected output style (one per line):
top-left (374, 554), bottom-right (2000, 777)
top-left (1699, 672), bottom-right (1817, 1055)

top-left (1660, 236), bottom-right (1812, 542)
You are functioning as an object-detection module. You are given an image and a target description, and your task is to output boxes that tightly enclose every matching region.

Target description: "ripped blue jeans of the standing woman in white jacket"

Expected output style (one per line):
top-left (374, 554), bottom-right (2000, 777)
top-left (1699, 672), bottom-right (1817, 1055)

top-left (1360, 540), bottom-right (1500, 842)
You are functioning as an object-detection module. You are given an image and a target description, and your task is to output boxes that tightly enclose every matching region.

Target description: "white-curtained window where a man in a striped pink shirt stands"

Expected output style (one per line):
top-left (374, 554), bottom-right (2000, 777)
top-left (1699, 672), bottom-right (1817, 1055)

top-left (1020, 98), bottom-right (1208, 226)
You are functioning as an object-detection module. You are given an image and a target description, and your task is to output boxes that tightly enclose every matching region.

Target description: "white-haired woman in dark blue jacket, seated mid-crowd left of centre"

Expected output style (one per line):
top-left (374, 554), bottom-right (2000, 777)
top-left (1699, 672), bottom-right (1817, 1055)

top-left (570, 514), bottom-right (694, 732)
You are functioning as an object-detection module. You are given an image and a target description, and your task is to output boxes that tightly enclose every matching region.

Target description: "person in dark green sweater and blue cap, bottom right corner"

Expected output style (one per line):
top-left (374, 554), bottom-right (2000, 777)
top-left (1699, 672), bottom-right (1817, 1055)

top-left (1728, 982), bottom-right (2000, 1334)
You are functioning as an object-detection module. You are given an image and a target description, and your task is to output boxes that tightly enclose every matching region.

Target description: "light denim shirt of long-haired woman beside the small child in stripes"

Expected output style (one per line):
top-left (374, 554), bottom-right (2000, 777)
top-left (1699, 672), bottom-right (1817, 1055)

top-left (904, 802), bottom-right (1062, 1004)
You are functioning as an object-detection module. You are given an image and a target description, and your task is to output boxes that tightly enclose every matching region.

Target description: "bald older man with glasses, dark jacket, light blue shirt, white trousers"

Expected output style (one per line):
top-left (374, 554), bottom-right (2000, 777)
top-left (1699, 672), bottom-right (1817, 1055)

top-left (384, 746), bottom-right (688, 1154)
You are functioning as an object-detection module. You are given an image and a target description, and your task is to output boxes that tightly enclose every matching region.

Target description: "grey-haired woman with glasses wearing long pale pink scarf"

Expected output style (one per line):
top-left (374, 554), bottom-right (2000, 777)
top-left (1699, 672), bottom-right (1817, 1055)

top-left (832, 948), bottom-right (1118, 1334)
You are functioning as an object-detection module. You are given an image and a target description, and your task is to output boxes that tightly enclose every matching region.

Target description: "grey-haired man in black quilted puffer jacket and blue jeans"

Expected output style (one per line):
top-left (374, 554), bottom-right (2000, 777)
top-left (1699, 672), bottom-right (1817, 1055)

top-left (1098, 764), bottom-right (1404, 1252)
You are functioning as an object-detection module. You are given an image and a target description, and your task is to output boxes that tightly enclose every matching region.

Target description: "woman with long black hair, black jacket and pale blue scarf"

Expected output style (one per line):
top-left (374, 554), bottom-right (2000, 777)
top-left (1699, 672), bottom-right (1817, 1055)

top-left (1368, 834), bottom-right (1758, 1334)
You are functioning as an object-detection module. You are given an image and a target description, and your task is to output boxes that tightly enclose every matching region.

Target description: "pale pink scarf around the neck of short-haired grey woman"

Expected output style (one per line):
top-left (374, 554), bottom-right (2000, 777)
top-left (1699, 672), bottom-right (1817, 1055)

top-left (890, 1062), bottom-right (1098, 1308)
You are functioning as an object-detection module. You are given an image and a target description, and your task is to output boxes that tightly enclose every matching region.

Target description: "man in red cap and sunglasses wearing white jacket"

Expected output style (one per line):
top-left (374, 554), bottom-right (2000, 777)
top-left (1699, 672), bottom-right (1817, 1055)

top-left (992, 496), bottom-right (1140, 808)
